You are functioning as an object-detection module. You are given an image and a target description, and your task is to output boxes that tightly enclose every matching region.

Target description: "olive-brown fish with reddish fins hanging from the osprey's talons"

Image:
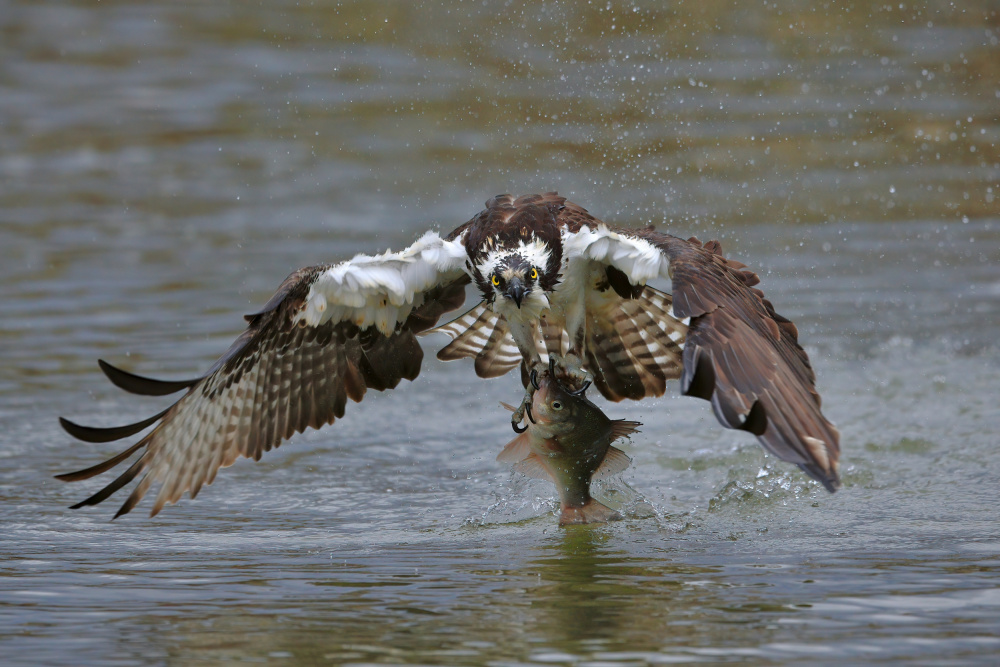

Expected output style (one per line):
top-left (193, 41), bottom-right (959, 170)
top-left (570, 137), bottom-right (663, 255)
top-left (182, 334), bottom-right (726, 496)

top-left (497, 370), bottom-right (642, 526)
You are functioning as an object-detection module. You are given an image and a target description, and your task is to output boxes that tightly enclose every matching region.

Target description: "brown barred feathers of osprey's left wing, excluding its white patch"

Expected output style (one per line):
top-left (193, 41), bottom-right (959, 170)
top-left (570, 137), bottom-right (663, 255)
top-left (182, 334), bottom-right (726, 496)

top-left (58, 267), bottom-right (469, 518)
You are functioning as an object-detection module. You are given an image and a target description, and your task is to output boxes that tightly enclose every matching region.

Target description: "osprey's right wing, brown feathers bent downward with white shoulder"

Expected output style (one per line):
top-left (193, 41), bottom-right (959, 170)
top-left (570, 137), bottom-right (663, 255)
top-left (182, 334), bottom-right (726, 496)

top-left (564, 224), bottom-right (840, 491)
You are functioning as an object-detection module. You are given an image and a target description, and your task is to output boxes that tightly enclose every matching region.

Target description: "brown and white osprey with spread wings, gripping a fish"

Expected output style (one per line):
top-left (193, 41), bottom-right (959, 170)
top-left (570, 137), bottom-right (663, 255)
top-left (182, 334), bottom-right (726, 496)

top-left (58, 192), bottom-right (840, 518)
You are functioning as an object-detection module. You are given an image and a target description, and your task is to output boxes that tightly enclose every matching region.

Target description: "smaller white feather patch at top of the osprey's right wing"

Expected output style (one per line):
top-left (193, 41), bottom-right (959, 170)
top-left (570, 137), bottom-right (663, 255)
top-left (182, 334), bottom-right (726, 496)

top-left (563, 224), bottom-right (670, 285)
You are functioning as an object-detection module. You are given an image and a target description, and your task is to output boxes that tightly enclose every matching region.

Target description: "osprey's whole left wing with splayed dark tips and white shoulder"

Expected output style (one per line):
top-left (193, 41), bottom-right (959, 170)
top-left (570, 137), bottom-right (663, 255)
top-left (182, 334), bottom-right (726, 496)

top-left (58, 233), bottom-right (470, 518)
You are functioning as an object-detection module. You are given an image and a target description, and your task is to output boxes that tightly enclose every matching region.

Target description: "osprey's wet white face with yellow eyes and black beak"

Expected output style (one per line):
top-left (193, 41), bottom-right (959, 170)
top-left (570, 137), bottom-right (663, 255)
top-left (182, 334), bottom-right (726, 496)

top-left (474, 239), bottom-right (559, 308)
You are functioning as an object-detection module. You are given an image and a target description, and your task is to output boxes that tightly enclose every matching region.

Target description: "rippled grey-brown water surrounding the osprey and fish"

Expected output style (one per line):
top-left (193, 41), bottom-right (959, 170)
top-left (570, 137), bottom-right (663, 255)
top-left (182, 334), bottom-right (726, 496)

top-left (0, 0), bottom-right (1000, 664)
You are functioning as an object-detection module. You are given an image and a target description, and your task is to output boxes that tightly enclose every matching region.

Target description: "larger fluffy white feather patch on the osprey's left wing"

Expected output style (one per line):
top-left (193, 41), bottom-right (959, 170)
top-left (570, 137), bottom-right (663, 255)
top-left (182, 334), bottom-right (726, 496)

top-left (295, 232), bottom-right (467, 336)
